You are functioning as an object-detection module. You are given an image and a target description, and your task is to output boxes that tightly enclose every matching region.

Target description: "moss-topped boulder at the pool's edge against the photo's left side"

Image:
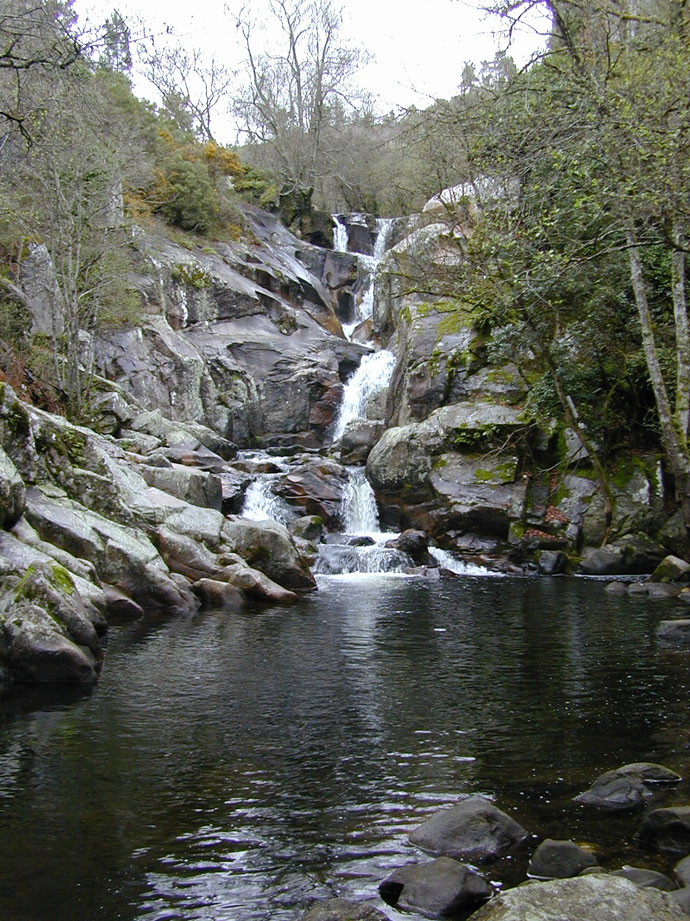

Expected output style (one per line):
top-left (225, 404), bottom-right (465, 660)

top-left (0, 563), bottom-right (103, 684)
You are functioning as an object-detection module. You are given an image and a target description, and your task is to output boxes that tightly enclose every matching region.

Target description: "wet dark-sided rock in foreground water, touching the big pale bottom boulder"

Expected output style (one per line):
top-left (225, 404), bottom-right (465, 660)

top-left (379, 857), bottom-right (493, 917)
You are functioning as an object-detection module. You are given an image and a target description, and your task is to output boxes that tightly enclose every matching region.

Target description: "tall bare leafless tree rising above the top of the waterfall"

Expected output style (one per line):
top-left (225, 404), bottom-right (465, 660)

top-left (234, 0), bottom-right (365, 200)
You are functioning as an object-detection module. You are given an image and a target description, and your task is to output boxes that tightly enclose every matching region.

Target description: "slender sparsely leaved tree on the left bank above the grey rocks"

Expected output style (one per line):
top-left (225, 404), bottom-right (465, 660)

top-left (0, 69), bottom-right (144, 417)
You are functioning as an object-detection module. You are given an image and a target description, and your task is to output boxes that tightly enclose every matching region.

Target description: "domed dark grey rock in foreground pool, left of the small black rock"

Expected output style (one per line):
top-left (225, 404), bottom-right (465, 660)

top-left (409, 796), bottom-right (527, 860)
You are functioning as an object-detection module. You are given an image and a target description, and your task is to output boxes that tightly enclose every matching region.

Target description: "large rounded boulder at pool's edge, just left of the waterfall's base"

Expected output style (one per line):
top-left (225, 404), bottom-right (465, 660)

top-left (222, 518), bottom-right (316, 592)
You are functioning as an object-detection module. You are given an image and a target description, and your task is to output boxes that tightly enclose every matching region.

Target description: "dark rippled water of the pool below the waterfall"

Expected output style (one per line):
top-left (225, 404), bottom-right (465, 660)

top-left (0, 576), bottom-right (690, 921)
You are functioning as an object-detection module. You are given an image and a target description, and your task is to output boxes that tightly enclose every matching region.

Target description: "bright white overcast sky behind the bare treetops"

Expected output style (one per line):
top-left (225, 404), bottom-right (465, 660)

top-left (75, 0), bottom-right (542, 142)
